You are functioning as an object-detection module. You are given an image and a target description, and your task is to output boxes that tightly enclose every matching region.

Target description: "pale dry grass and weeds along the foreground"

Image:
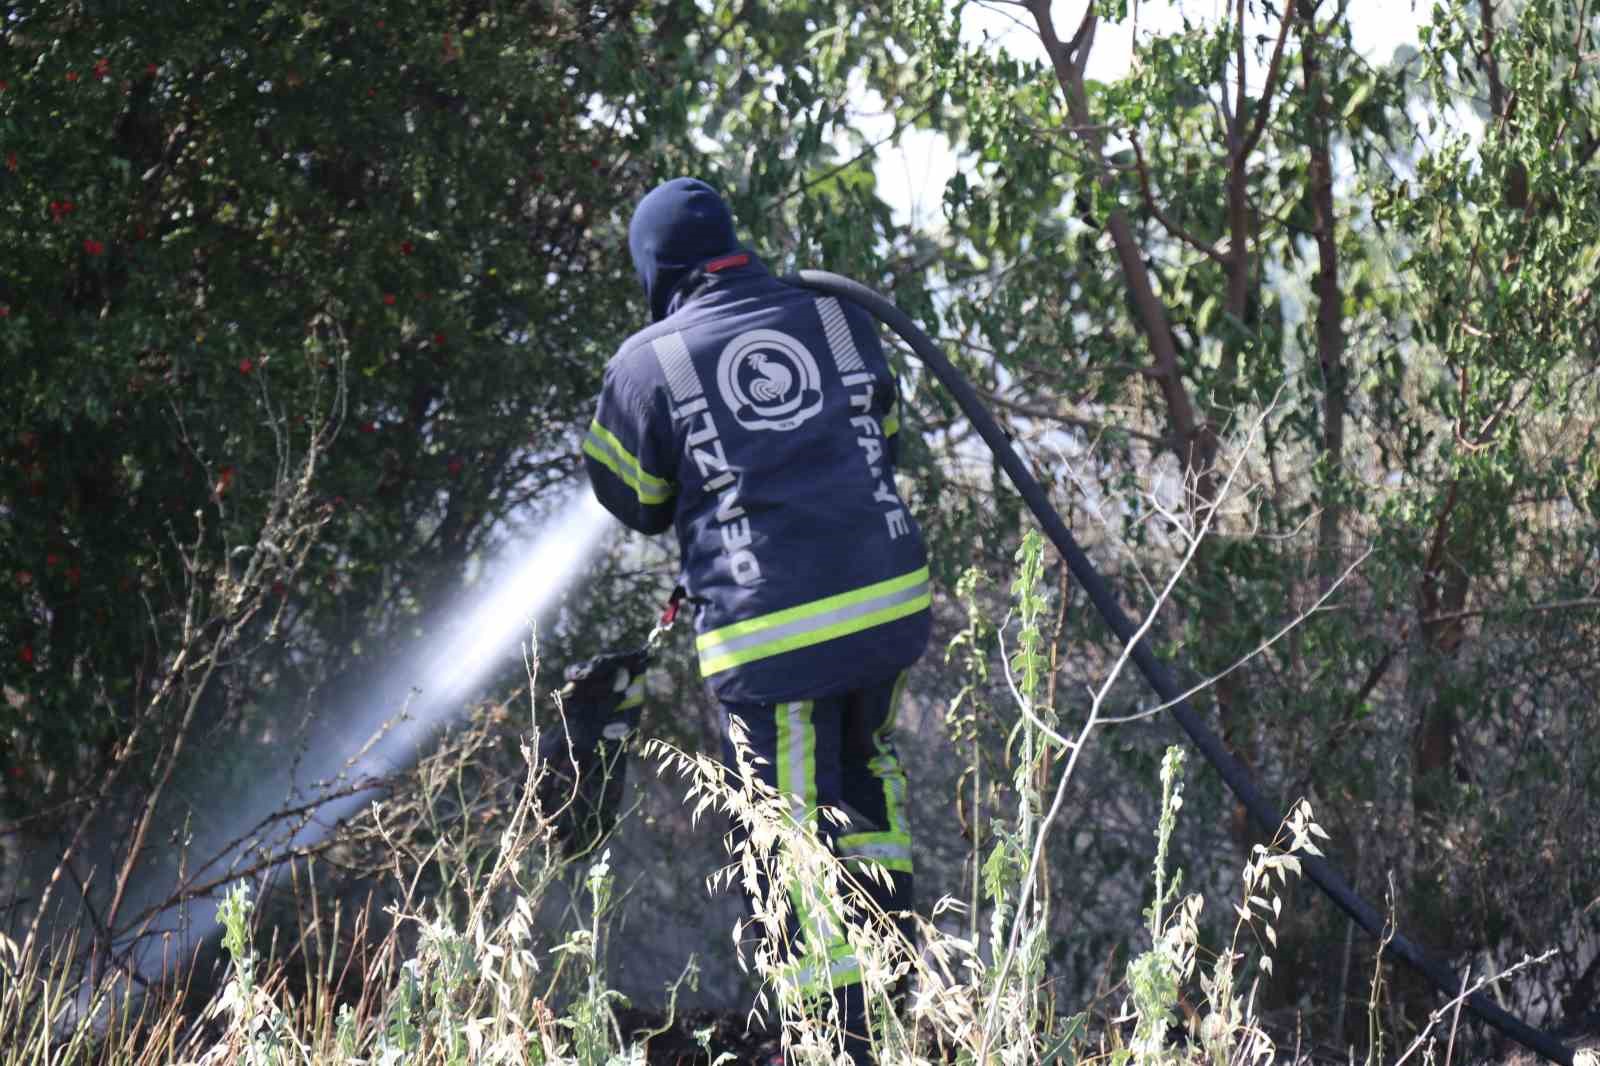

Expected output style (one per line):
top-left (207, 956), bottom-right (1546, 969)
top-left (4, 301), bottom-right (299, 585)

top-left (0, 539), bottom-right (1536, 1066)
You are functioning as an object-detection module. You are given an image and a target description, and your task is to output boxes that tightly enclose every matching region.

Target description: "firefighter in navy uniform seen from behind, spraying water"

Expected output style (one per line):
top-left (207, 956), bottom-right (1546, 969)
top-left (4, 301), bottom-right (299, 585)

top-left (582, 178), bottom-right (930, 1061)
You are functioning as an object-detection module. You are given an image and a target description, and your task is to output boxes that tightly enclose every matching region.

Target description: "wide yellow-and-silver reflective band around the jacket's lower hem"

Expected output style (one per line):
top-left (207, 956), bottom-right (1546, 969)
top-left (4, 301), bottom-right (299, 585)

top-left (694, 567), bottom-right (930, 677)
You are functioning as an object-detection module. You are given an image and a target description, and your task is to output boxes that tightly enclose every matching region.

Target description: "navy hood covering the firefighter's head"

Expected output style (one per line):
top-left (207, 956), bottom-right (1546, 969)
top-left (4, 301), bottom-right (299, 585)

top-left (627, 178), bottom-right (739, 322)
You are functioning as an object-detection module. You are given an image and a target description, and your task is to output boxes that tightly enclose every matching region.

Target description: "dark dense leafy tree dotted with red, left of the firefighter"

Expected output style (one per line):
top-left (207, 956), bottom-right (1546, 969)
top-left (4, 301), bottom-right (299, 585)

top-left (0, 3), bottom-right (694, 953)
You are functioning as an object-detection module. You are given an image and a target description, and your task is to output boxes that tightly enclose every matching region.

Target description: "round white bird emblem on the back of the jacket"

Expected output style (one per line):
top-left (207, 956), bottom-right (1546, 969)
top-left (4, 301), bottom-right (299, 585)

top-left (717, 330), bottom-right (822, 431)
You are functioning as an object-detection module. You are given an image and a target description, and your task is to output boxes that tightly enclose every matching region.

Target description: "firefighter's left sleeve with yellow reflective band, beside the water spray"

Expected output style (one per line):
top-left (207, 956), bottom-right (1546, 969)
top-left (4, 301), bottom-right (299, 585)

top-left (584, 365), bottom-right (678, 533)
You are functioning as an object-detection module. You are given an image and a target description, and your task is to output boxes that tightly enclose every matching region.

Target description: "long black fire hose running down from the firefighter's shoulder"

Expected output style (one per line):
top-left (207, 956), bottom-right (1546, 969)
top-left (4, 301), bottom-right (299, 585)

top-left (787, 271), bottom-right (1573, 1066)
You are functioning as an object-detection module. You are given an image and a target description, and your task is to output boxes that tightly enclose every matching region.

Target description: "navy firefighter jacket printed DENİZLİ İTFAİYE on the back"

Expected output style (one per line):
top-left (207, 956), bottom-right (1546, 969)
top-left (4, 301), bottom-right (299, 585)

top-left (582, 182), bottom-right (930, 703)
